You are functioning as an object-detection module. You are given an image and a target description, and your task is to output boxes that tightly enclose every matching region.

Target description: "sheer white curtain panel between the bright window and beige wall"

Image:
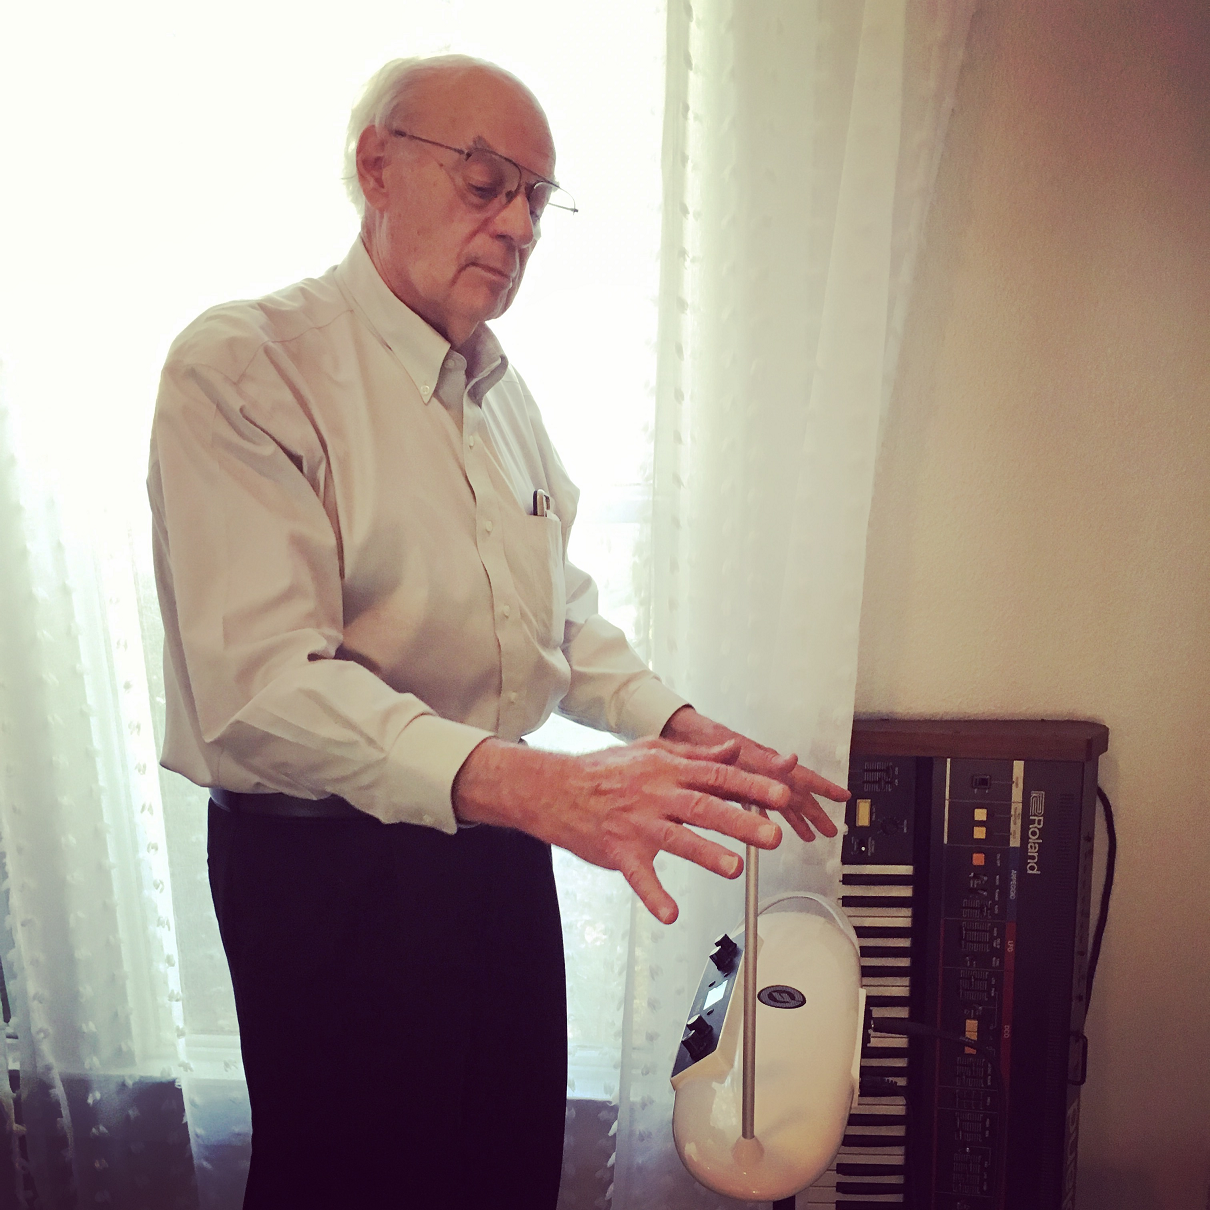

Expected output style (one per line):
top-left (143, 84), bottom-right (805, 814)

top-left (612, 0), bottom-right (973, 1210)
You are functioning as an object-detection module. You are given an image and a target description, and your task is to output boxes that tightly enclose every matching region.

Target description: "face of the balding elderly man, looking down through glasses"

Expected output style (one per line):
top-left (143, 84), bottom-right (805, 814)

top-left (358, 68), bottom-right (554, 347)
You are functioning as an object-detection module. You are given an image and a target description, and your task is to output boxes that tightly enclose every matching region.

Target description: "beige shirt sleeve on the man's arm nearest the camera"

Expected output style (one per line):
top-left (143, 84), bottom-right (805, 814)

top-left (149, 361), bottom-right (491, 832)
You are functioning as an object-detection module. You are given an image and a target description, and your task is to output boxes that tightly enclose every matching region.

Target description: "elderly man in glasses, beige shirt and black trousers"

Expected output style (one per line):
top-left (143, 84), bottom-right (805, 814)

top-left (149, 57), bottom-right (845, 1210)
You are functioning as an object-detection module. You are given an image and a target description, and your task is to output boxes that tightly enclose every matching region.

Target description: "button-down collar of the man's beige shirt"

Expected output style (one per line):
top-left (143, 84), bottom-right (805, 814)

top-left (336, 236), bottom-right (508, 403)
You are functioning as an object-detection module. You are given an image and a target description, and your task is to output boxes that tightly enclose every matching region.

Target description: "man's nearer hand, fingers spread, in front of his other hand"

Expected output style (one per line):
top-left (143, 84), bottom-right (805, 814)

top-left (451, 739), bottom-right (790, 924)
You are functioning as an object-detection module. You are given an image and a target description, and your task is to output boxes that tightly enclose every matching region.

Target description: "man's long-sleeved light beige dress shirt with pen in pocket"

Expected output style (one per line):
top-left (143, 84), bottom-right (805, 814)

top-left (148, 241), bottom-right (684, 832)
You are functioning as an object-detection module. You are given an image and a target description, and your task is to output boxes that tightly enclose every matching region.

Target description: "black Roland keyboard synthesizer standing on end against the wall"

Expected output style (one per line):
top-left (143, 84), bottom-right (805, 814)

top-left (797, 719), bottom-right (1108, 1210)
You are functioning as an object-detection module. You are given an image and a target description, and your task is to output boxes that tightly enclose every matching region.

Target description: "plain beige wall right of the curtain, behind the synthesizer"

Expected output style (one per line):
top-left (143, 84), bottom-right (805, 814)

top-left (857, 0), bottom-right (1210, 1210)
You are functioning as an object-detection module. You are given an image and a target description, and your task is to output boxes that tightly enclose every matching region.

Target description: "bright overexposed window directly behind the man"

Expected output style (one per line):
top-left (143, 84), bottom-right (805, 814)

top-left (0, 0), bottom-right (664, 1095)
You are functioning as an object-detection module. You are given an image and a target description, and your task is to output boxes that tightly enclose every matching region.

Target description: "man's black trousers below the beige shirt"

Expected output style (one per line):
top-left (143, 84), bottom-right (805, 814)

top-left (209, 803), bottom-right (567, 1210)
